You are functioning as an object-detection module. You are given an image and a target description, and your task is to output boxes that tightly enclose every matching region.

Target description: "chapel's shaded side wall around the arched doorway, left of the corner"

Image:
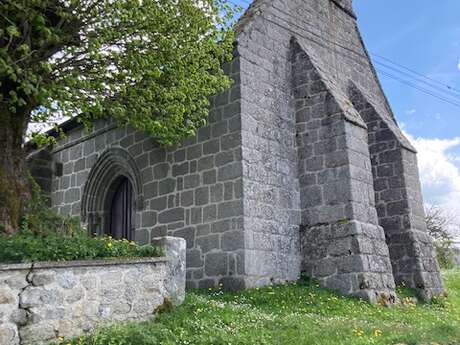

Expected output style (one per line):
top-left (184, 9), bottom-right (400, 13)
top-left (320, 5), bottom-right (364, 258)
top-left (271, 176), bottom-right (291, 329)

top-left (26, 56), bottom-right (244, 288)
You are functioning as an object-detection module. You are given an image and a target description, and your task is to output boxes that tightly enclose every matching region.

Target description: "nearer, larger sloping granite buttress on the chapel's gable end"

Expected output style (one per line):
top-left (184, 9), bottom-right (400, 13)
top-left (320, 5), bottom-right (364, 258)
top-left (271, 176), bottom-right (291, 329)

top-left (292, 40), bottom-right (395, 303)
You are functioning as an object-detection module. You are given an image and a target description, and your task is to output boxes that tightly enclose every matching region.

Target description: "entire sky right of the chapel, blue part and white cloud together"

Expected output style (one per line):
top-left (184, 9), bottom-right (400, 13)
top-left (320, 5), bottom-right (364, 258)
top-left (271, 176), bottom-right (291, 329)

top-left (354, 0), bottom-right (460, 237)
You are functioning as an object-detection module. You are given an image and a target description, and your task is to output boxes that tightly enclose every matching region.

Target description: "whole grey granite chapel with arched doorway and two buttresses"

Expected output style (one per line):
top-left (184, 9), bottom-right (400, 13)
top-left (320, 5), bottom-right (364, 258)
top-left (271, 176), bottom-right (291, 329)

top-left (28, 0), bottom-right (443, 302)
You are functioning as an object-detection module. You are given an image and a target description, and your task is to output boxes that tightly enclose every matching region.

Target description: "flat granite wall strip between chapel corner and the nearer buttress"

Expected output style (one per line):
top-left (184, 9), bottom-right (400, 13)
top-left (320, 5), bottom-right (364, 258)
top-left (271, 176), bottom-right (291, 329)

top-left (238, 22), bottom-right (300, 287)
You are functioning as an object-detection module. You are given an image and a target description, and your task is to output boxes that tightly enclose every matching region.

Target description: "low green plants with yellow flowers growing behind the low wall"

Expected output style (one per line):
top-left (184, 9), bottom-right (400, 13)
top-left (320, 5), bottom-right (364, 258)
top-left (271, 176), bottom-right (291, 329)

top-left (0, 179), bottom-right (162, 263)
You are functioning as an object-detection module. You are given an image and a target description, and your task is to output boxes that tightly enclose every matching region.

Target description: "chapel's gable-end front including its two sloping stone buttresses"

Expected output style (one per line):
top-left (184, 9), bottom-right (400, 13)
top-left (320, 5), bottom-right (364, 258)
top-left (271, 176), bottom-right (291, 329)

top-left (237, 0), bottom-right (443, 302)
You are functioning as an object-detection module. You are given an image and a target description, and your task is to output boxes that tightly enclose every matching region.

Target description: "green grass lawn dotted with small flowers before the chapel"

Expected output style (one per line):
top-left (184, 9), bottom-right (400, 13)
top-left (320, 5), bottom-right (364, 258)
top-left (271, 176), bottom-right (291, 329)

top-left (62, 270), bottom-right (460, 345)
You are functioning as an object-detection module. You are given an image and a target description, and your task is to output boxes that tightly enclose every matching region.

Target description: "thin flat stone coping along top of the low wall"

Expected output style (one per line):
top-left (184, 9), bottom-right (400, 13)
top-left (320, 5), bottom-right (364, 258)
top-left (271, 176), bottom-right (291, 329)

top-left (0, 256), bottom-right (170, 271)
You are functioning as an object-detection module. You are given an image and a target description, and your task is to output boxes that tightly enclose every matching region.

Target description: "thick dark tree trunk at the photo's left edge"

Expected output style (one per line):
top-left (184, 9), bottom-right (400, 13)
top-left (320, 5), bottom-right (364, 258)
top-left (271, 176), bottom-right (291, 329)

top-left (0, 109), bottom-right (31, 234)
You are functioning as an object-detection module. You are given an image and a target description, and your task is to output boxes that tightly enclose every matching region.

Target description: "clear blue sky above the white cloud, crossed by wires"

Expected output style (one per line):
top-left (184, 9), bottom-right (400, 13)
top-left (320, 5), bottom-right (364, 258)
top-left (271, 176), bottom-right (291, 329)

top-left (355, 0), bottom-right (460, 140)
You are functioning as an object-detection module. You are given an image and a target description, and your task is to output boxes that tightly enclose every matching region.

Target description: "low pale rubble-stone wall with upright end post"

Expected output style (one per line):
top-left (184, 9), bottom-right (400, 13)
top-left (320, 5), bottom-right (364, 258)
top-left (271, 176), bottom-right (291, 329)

top-left (0, 237), bottom-right (186, 345)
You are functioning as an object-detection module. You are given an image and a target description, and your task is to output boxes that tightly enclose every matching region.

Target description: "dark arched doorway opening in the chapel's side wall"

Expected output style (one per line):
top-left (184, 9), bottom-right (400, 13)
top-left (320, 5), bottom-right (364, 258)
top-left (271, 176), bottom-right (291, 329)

top-left (105, 176), bottom-right (134, 241)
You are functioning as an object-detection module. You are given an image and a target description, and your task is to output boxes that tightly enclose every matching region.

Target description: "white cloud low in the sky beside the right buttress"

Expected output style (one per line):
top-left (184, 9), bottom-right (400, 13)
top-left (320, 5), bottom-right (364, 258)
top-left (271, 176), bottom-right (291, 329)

top-left (405, 133), bottom-right (460, 240)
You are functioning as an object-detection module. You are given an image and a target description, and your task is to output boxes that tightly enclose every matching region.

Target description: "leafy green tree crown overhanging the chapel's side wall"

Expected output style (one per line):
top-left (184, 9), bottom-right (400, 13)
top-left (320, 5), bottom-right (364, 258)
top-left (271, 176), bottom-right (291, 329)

top-left (0, 0), bottom-right (234, 145)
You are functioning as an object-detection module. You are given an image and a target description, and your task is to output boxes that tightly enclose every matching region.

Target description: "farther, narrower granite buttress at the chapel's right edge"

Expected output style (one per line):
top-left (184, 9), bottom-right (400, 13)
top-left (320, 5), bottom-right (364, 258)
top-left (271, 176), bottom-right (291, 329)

top-left (350, 85), bottom-right (443, 299)
